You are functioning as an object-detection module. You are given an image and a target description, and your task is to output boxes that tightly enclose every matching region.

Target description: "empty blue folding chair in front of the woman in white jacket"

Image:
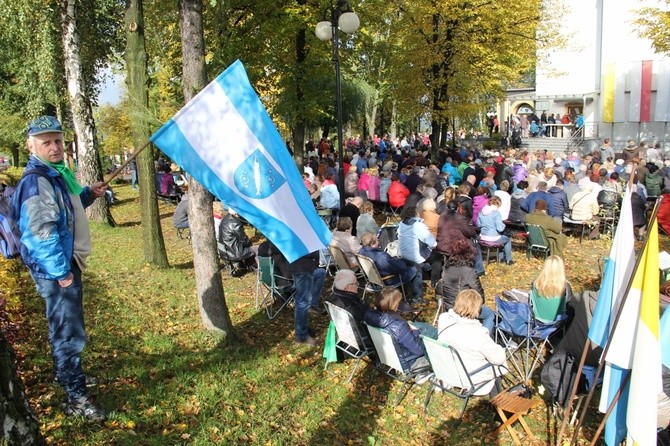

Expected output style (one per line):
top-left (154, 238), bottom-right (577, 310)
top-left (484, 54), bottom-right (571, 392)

top-left (495, 296), bottom-right (567, 382)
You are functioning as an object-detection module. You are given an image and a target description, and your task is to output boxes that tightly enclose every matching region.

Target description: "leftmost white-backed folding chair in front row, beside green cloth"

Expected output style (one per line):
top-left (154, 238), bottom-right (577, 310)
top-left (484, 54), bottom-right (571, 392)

top-left (326, 302), bottom-right (375, 382)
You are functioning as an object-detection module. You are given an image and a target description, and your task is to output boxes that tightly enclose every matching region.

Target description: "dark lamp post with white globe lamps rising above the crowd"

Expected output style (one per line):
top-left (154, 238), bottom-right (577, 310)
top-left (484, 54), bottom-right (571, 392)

top-left (314, 0), bottom-right (360, 209)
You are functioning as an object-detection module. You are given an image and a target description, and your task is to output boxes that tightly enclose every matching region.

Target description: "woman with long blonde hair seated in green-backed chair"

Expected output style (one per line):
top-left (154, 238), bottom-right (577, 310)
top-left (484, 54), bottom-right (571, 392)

top-left (530, 255), bottom-right (572, 323)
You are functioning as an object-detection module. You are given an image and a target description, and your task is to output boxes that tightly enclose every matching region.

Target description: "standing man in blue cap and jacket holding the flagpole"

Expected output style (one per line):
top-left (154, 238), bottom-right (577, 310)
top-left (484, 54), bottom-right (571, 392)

top-left (12, 116), bottom-right (106, 420)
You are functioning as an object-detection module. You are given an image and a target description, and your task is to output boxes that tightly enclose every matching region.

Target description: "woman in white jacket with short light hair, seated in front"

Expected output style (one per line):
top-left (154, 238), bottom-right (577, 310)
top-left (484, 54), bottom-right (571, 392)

top-left (437, 289), bottom-right (506, 395)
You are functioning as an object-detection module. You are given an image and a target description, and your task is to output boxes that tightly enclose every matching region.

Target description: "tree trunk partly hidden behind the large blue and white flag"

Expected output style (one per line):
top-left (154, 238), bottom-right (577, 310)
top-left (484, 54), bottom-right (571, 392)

top-left (179, 0), bottom-right (234, 337)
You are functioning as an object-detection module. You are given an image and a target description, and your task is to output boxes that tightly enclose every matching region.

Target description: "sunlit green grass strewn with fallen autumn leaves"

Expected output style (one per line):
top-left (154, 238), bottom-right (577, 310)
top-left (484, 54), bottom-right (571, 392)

top-left (0, 186), bottom-right (620, 445)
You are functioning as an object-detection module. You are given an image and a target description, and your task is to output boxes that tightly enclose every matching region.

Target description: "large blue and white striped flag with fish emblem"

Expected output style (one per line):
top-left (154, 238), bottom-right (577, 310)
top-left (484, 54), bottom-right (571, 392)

top-left (151, 60), bottom-right (331, 262)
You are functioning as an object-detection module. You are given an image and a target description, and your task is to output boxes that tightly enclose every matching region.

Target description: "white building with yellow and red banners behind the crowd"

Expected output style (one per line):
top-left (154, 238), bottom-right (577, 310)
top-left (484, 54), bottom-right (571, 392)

top-left (500, 0), bottom-right (670, 150)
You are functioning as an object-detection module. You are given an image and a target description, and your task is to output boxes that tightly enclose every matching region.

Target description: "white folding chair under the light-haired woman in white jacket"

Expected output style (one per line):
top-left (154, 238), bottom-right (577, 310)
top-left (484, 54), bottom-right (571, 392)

top-left (421, 335), bottom-right (496, 421)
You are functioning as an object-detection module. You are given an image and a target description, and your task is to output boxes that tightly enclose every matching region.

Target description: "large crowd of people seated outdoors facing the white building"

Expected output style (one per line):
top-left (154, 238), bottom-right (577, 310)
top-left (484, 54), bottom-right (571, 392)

top-left (180, 137), bottom-right (670, 440)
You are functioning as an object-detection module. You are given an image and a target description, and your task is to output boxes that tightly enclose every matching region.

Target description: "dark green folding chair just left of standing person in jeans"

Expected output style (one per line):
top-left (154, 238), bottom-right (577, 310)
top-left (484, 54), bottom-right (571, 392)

top-left (256, 256), bottom-right (296, 319)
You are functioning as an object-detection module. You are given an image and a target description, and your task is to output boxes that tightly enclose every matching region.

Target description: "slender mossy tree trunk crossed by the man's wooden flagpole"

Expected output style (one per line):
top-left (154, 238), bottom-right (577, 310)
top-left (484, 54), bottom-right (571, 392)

top-left (125, 0), bottom-right (168, 268)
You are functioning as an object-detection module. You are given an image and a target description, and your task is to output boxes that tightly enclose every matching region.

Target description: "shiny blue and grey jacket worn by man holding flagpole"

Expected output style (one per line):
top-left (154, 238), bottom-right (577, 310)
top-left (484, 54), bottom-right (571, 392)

top-left (12, 156), bottom-right (95, 280)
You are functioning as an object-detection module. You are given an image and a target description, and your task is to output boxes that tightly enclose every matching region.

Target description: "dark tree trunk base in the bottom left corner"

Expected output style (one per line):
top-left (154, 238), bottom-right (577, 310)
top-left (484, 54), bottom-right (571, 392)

top-left (0, 333), bottom-right (46, 445)
